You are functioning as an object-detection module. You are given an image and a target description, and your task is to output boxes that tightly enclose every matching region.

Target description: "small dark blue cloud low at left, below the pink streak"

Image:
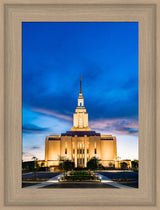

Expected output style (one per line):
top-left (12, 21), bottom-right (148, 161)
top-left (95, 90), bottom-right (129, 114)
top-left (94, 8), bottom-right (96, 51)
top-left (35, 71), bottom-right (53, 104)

top-left (22, 124), bottom-right (49, 134)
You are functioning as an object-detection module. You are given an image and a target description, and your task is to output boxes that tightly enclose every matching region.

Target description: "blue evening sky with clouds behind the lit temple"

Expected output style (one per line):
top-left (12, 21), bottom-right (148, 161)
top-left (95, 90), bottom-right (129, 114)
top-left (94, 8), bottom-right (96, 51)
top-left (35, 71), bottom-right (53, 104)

top-left (22, 22), bottom-right (138, 160)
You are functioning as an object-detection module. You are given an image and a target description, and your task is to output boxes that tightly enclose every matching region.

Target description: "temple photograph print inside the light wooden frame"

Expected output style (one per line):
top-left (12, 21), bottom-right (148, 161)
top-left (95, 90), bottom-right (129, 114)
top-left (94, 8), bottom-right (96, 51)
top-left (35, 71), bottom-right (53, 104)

top-left (22, 22), bottom-right (139, 189)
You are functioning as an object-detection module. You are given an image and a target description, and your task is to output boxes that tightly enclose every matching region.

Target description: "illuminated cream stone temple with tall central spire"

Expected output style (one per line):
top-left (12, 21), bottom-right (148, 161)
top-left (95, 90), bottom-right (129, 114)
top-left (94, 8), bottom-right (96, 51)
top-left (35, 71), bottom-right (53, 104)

top-left (45, 77), bottom-right (117, 168)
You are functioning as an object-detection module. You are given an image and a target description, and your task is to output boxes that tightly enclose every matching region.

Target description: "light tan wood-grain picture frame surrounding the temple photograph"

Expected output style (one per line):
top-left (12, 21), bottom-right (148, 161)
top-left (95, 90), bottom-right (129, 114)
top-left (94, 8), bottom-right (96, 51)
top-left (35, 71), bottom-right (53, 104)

top-left (0, 0), bottom-right (160, 209)
